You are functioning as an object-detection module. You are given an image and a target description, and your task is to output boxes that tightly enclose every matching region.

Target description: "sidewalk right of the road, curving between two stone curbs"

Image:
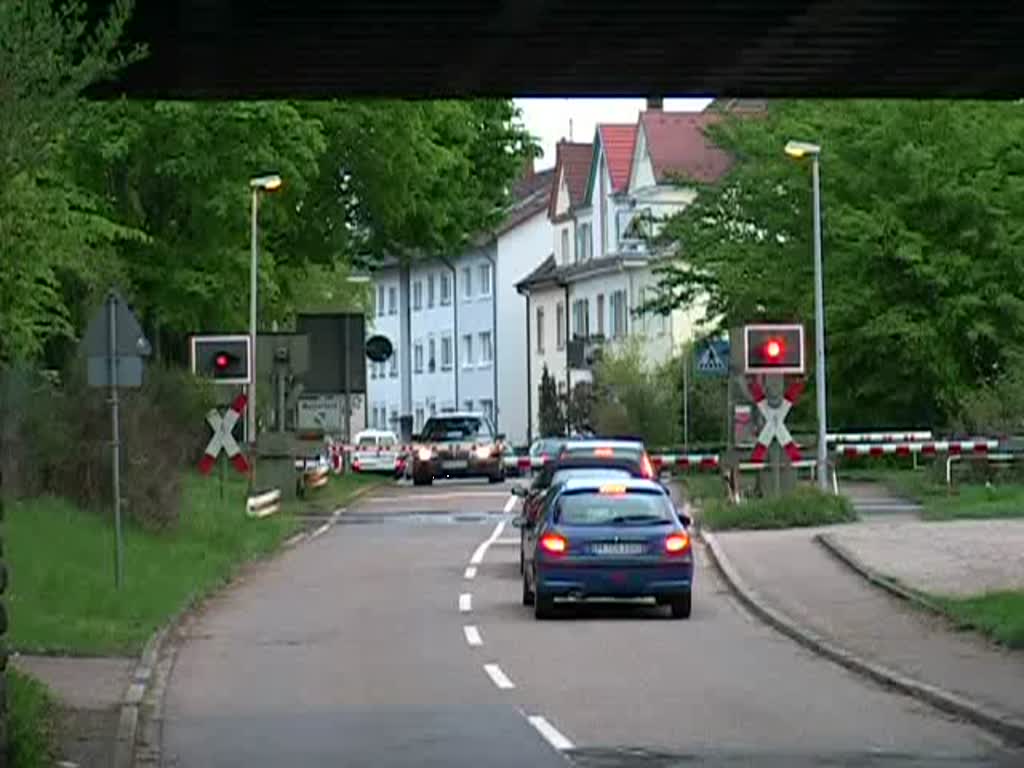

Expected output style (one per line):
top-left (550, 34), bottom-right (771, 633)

top-left (715, 522), bottom-right (1024, 733)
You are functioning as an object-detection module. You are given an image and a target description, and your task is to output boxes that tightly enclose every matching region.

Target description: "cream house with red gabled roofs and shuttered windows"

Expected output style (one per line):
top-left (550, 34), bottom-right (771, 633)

top-left (518, 102), bottom-right (731, 437)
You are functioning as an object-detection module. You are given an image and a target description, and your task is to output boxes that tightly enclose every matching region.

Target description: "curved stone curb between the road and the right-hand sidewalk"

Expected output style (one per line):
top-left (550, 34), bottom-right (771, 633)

top-left (699, 530), bottom-right (1024, 746)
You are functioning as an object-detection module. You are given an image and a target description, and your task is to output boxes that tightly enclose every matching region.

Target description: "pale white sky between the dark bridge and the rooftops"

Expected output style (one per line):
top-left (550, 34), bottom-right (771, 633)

top-left (515, 98), bottom-right (712, 171)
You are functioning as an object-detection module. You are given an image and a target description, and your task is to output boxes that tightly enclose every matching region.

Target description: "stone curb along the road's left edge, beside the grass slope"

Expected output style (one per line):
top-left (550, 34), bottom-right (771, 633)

top-left (125, 484), bottom-right (378, 768)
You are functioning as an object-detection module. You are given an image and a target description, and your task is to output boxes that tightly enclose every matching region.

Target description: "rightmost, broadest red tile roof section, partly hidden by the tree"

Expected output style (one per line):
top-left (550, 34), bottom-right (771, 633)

top-left (640, 110), bottom-right (732, 183)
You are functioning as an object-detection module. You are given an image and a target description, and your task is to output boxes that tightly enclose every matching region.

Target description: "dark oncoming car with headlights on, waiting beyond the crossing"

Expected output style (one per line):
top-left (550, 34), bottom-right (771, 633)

top-left (412, 413), bottom-right (505, 485)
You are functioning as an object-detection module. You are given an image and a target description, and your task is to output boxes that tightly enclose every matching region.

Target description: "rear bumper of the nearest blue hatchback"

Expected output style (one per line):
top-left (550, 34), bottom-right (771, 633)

top-left (537, 560), bottom-right (693, 599)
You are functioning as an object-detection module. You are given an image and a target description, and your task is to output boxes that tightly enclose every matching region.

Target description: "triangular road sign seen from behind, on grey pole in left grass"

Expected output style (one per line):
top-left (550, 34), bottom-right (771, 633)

top-left (82, 289), bottom-right (151, 589)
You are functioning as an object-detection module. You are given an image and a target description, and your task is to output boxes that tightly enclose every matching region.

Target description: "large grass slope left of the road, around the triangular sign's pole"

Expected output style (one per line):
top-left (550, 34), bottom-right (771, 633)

top-left (5, 474), bottom-right (382, 654)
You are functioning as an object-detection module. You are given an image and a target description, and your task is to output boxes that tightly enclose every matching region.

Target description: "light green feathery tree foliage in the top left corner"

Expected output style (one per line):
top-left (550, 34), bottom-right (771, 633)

top-left (0, 0), bottom-right (143, 359)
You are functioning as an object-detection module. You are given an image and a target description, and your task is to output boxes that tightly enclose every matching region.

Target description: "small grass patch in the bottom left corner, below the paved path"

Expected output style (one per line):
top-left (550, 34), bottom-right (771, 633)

top-left (6, 668), bottom-right (56, 768)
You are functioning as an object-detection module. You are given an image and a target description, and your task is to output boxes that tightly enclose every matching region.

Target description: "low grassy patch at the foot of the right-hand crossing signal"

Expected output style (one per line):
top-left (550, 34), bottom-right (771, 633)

top-left (701, 486), bottom-right (857, 530)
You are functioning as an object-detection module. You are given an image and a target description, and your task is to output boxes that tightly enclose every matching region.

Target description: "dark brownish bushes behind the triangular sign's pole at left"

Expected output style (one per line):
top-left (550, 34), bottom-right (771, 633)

top-left (0, 359), bottom-right (213, 528)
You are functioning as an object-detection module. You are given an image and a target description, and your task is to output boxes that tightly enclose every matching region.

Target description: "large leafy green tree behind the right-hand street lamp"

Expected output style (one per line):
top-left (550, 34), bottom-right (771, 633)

top-left (655, 100), bottom-right (1024, 428)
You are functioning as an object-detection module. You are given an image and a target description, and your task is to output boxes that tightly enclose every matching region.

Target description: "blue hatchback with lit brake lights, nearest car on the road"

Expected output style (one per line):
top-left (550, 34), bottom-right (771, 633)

top-left (514, 476), bottom-right (693, 618)
